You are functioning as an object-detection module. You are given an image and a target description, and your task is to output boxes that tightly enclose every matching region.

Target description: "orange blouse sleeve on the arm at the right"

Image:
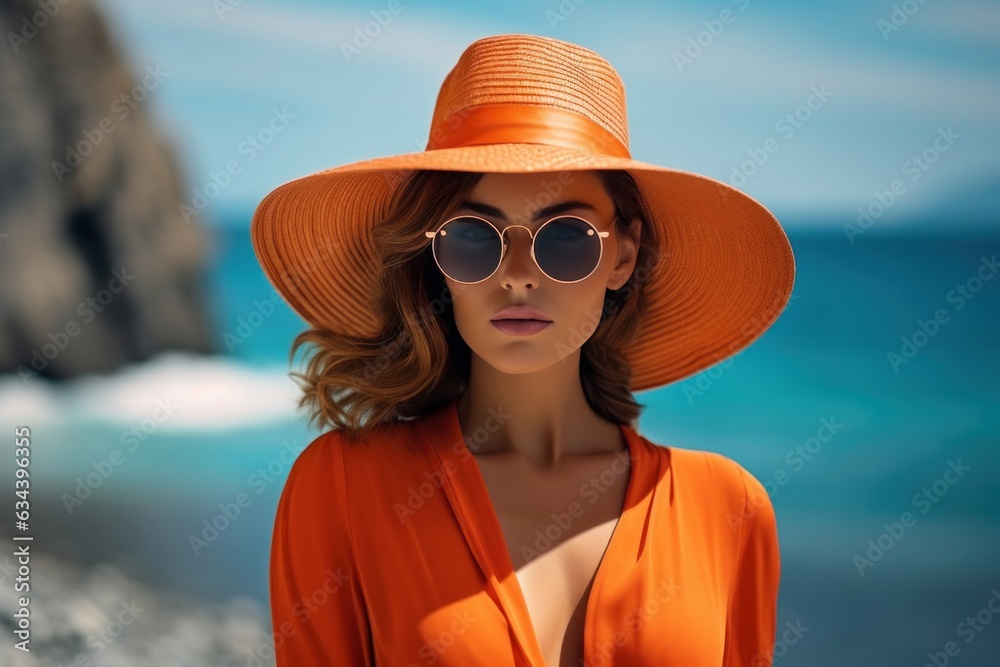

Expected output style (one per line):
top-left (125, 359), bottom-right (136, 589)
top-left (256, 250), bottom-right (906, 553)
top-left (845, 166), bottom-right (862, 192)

top-left (722, 467), bottom-right (781, 667)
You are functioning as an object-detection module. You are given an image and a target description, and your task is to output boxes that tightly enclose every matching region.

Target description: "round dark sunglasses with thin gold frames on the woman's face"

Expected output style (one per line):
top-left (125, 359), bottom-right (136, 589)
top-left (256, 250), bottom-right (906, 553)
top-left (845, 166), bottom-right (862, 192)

top-left (424, 215), bottom-right (618, 285)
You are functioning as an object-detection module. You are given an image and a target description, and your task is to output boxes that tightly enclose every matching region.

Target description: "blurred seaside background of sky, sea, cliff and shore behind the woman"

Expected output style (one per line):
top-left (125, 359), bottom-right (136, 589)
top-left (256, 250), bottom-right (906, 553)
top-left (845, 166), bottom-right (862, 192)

top-left (0, 0), bottom-right (1000, 667)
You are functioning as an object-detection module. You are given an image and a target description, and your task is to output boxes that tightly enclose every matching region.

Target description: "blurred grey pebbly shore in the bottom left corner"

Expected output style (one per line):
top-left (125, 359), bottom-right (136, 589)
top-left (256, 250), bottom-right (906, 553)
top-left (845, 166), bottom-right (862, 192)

top-left (0, 551), bottom-right (274, 667)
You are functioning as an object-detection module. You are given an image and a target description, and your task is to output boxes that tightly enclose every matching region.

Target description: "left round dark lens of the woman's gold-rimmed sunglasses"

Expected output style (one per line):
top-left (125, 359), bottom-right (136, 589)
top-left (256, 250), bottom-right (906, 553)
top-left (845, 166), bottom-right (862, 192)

top-left (434, 218), bottom-right (503, 283)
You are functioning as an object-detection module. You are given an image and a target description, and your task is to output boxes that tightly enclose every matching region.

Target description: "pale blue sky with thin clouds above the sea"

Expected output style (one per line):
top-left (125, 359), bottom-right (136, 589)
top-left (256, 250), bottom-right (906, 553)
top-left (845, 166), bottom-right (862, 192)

top-left (90, 0), bottom-right (1000, 229)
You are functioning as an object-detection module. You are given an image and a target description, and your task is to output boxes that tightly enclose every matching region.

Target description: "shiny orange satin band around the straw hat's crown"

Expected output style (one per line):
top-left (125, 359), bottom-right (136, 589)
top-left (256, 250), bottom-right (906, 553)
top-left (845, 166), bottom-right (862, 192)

top-left (427, 104), bottom-right (632, 159)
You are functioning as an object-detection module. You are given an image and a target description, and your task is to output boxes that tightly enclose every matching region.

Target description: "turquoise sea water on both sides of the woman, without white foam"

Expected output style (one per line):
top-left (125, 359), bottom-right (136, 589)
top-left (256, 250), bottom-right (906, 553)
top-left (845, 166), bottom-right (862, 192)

top-left (11, 222), bottom-right (1000, 665)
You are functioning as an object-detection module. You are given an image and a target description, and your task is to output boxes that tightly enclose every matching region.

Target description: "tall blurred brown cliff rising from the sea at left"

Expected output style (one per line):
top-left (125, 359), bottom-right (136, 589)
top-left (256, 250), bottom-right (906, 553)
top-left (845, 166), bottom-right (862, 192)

top-left (0, 0), bottom-right (218, 381)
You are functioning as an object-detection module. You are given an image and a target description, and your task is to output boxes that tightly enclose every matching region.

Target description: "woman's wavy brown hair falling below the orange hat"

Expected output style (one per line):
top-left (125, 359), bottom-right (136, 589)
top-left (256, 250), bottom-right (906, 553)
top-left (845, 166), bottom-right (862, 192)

top-left (289, 170), bottom-right (660, 441)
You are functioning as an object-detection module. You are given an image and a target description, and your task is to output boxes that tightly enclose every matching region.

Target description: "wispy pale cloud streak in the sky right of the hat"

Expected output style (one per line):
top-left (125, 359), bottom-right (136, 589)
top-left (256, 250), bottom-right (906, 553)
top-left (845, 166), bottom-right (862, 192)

top-left (615, 8), bottom-right (1000, 120)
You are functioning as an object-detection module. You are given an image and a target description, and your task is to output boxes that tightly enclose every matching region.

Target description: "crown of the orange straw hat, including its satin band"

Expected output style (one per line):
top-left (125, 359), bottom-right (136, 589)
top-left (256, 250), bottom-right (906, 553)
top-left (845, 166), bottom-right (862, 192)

top-left (427, 34), bottom-right (629, 155)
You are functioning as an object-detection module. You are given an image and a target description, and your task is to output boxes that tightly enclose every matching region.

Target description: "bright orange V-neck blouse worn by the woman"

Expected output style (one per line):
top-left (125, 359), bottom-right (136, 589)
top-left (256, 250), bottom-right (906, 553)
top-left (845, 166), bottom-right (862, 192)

top-left (270, 401), bottom-right (780, 667)
